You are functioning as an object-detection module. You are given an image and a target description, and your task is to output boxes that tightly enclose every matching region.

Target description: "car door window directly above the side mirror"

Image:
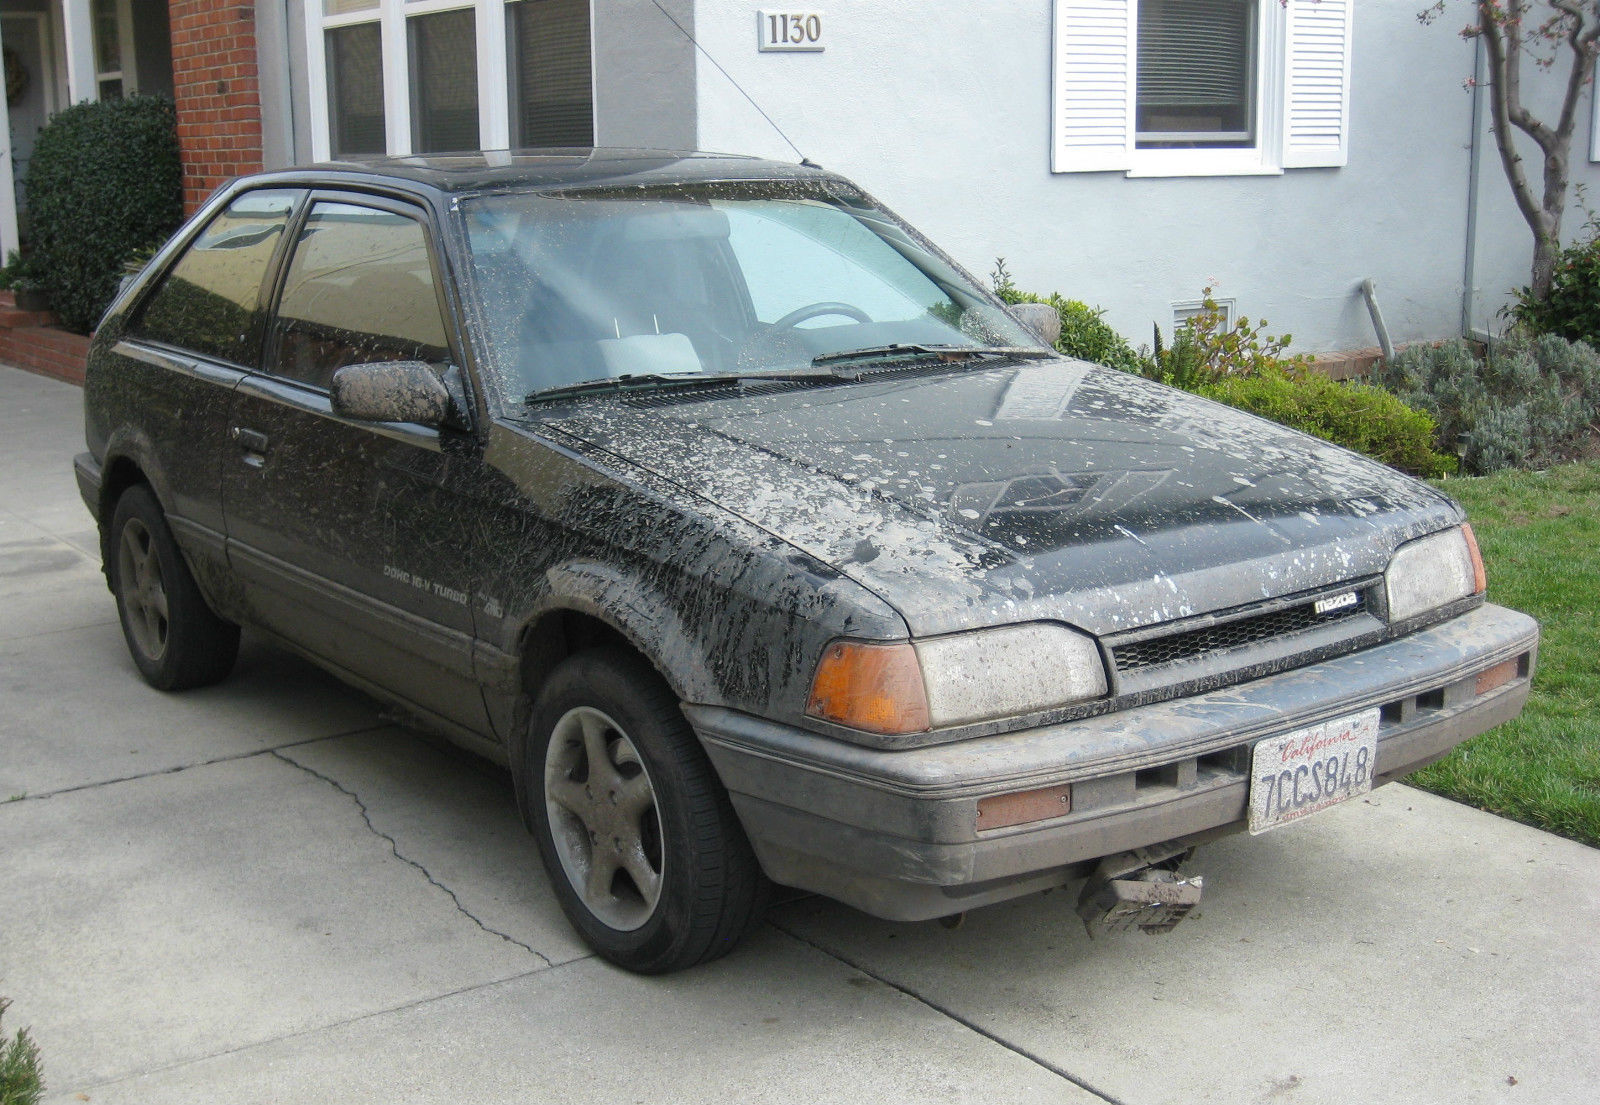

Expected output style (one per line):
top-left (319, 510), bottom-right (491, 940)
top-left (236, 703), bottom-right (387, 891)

top-left (265, 203), bottom-right (450, 387)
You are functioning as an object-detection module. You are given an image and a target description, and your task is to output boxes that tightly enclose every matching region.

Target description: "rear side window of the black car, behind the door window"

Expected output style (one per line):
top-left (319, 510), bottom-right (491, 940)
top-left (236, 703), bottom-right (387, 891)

top-left (131, 189), bottom-right (301, 368)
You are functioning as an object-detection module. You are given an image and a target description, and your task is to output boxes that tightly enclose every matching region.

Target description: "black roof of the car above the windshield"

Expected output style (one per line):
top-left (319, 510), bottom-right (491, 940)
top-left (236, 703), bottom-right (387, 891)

top-left (248, 147), bottom-right (842, 193)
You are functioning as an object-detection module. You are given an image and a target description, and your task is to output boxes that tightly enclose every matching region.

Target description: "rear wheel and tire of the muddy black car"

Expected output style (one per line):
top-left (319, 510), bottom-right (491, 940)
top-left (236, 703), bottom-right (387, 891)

top-left (106, 485), bottom-right (238, 691)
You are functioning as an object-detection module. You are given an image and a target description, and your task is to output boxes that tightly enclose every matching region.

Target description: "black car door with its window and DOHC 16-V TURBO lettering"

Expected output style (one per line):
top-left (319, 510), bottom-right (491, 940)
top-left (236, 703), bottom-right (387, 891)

top-left (222, 193), bottom-right (486, 732)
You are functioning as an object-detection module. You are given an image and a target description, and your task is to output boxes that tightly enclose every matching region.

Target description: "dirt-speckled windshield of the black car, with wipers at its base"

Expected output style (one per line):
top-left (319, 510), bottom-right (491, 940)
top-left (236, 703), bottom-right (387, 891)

top-left (461, 182), bottom-right (1038, 403)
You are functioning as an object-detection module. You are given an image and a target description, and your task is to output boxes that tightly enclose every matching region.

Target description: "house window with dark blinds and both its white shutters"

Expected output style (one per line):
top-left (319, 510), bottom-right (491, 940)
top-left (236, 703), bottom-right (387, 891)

top-left (1051, 0), bottom-right (1355, 176)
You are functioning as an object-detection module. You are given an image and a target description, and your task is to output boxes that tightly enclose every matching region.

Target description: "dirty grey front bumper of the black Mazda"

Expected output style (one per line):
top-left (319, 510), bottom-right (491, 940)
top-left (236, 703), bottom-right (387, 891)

top-left (685, 606), bottom-right (1539, 921)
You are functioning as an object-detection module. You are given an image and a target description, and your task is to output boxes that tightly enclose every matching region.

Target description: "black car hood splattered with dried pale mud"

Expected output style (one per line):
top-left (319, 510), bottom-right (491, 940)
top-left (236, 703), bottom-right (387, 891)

top-left (541, 358), bottom-right (1461, 636)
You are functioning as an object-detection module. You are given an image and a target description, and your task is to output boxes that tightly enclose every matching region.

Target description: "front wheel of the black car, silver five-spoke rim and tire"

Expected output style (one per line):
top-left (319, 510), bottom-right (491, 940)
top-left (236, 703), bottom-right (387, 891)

top-left (520, 648), bottom-right (766, 974)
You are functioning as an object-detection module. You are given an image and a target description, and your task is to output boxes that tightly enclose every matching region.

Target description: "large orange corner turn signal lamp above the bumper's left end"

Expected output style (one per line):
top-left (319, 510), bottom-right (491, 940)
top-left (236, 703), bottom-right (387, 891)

top-left (805, 641), bottom-right (933, 734)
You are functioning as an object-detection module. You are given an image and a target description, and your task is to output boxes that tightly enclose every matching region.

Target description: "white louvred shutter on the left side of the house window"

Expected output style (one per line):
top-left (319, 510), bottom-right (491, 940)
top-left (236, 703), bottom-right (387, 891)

top-left (1050, 0), bottom-right (1134, 173)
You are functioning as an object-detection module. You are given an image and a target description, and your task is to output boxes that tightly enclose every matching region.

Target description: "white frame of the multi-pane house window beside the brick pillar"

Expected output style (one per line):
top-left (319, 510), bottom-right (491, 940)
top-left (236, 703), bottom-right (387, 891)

top-left (306, 0), bottom-right (598, 162)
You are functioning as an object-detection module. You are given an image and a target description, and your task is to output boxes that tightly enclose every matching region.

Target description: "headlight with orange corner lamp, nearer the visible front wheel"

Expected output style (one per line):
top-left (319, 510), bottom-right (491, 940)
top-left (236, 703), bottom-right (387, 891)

top-left (806, 624), bottom-right (1106, 734)
